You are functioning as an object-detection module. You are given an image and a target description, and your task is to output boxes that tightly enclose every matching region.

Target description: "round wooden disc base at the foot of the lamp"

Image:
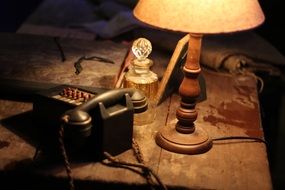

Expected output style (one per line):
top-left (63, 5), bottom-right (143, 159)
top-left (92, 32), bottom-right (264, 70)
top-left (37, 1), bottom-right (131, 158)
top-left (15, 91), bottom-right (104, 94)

top-left (155, 126), bottom-right (212, 154)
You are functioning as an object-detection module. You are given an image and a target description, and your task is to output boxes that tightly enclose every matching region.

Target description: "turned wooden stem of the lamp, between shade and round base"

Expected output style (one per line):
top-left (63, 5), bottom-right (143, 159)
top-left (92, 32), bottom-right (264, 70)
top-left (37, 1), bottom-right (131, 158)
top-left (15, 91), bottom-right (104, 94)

top-left (176, 34), bottom-right (202, 133)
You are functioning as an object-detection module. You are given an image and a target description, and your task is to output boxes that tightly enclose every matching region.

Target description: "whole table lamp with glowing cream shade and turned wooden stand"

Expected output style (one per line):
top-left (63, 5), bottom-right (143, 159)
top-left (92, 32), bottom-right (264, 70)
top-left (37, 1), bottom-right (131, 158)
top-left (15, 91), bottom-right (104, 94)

top-left (133, 0), bottom-right (265, 154)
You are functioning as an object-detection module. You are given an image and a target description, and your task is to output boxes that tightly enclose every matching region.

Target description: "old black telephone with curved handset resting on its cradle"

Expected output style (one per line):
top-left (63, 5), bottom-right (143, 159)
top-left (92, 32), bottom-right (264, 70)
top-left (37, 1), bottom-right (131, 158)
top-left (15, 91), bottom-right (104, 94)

top-left (33, 85), bottom-right (147, 158)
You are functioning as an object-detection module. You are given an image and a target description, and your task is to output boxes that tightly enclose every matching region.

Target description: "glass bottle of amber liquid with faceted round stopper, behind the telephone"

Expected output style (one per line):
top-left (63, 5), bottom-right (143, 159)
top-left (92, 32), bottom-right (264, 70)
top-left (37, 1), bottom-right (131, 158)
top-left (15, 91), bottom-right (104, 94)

top-left (123, 38), bottom-right (158, 125)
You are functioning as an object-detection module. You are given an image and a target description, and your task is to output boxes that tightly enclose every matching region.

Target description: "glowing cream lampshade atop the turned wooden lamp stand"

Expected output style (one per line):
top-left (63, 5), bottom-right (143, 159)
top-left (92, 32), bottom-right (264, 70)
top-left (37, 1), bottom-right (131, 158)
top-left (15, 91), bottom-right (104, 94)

top-left (134, 0), bottom-right (265, 34)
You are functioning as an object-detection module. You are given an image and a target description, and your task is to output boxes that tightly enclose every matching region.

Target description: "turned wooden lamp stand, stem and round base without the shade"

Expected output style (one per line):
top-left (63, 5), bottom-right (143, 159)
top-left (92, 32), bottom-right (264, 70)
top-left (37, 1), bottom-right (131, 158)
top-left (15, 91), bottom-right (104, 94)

top-left (155, 34), bottom-right (212, 154)
